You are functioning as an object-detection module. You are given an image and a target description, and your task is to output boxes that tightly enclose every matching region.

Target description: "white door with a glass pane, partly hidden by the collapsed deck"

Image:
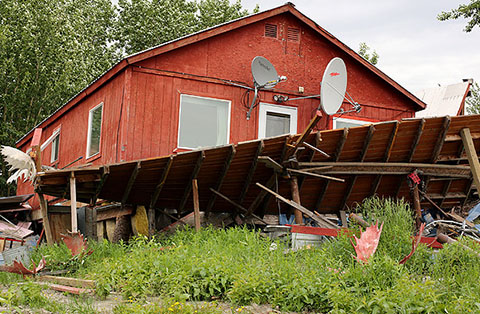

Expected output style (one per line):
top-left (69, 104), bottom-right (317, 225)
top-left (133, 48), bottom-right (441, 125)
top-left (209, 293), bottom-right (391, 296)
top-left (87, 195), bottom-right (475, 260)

top-left (258, 103), bottom-right (297, 138)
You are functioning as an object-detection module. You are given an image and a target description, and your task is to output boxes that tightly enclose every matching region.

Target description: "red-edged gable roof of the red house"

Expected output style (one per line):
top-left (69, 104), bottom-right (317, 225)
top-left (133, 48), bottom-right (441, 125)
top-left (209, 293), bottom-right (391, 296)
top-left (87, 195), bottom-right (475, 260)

top-left (16, 2), bottom-right (426, 146)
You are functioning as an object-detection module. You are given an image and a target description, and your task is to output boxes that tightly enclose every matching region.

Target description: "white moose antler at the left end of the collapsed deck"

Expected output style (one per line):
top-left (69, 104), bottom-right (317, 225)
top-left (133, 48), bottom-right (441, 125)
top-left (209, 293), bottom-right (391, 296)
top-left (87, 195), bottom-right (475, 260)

top-left (0, 145), bottom-right (37, 183)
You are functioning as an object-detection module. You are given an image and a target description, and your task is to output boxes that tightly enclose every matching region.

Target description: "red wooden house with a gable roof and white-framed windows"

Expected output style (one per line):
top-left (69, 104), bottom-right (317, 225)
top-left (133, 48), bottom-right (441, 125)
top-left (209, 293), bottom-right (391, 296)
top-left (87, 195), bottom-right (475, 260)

top-left (17, 3), bottom-right (425, 206)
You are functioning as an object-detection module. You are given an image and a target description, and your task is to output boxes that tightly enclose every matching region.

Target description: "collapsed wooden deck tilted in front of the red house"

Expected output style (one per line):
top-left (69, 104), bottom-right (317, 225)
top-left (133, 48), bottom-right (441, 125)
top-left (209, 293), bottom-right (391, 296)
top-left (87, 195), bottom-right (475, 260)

top-left (35, 115), bottom-right (480, 221)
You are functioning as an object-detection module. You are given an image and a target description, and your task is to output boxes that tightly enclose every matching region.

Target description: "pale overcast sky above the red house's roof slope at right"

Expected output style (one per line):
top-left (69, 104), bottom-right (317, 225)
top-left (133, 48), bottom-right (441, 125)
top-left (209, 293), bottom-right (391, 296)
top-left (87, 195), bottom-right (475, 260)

top-left (238, 0), bottom-right (480, 92)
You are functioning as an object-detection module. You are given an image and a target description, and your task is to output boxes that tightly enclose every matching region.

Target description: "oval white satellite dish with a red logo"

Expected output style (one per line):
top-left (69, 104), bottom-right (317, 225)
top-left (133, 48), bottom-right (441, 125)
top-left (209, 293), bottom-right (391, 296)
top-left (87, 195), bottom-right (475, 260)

top-left (320, 58), bottom-right (347, 115)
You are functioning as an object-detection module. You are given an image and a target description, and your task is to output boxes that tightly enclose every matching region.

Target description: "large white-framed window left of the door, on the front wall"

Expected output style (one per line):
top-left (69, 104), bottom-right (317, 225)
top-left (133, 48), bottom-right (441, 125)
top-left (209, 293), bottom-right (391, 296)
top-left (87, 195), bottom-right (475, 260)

top-left (178, 95), bottom-right (230, 149)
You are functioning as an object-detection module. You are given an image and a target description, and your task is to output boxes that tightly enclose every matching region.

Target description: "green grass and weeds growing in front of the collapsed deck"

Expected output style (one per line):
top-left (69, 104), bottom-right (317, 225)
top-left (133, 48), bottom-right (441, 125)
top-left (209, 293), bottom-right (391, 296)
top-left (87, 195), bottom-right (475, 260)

top-left (16, 198), bottom-right (480, 313)
